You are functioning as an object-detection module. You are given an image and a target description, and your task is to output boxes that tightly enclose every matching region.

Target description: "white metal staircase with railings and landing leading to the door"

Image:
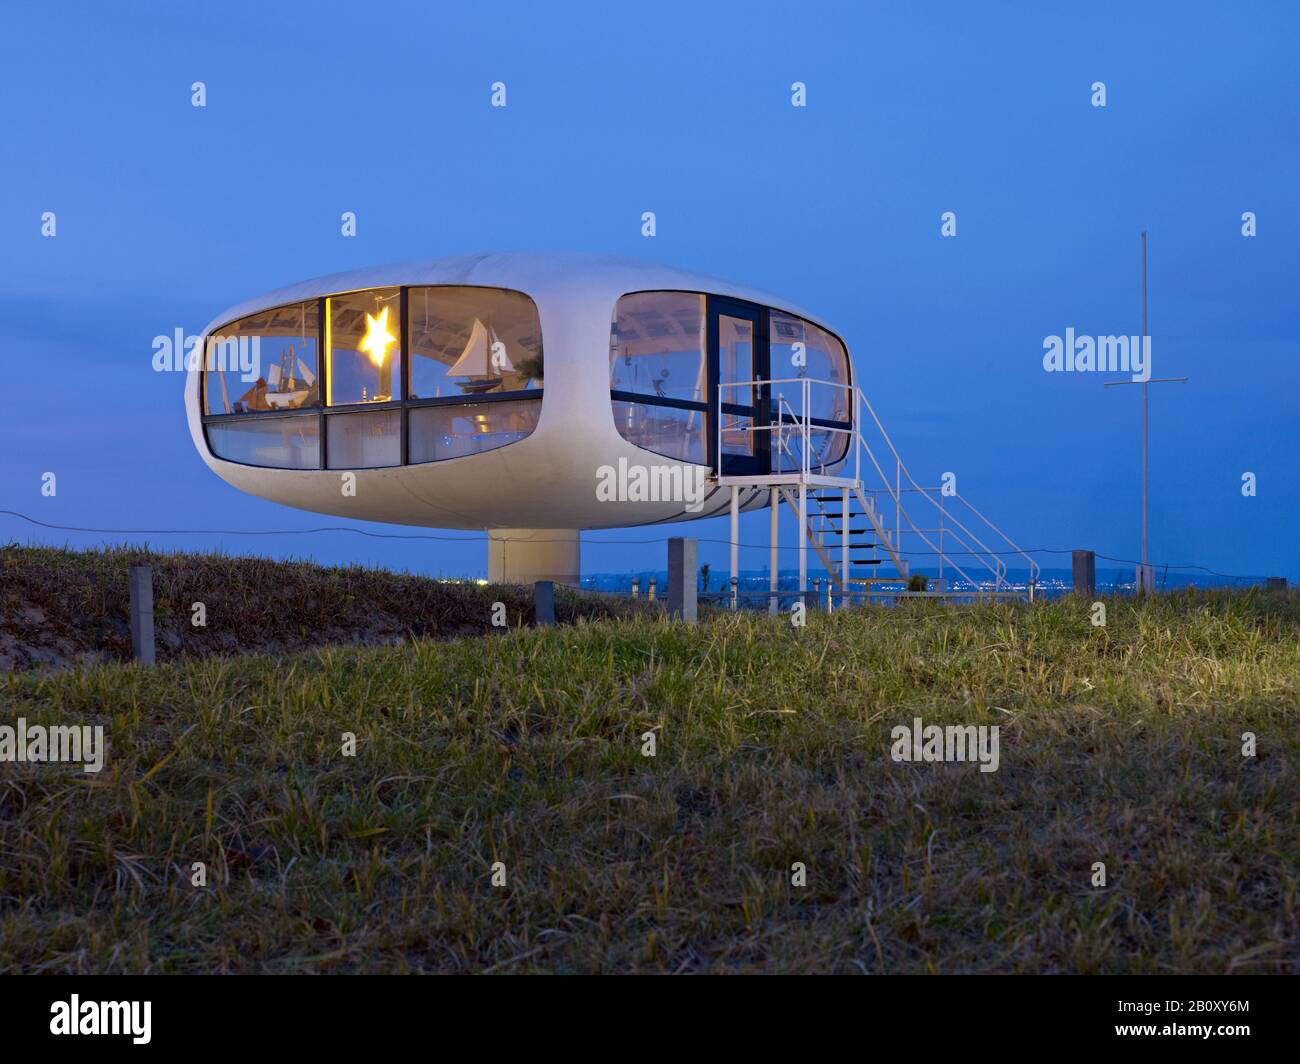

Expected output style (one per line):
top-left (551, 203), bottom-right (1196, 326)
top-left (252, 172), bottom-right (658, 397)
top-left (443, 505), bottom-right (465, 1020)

top-left (714, 377), bottom-right (1040, 600)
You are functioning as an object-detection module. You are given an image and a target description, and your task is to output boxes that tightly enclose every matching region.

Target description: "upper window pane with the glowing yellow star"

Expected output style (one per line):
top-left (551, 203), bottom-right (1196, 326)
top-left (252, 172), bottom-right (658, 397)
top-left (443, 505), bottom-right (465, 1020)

top-left (325, 287), bottom-right (402, 406)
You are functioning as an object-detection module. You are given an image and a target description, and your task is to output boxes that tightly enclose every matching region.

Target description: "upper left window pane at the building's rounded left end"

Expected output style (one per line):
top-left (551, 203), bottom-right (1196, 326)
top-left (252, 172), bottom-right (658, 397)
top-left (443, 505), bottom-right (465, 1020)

top-left (203, 299), bottom-right (320, 414)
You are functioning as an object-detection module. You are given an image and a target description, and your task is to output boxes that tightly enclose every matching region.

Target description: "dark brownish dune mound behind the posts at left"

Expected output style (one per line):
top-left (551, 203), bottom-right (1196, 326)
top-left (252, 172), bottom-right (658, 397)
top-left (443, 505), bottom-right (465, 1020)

top-left (0, 544), bottom-right (644, 671)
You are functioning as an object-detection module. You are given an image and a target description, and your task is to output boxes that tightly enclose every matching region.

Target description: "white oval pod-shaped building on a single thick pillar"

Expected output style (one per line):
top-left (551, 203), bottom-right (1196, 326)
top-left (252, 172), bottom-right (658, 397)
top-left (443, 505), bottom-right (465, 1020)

top-left (186, 254), bottom-right (857, 583)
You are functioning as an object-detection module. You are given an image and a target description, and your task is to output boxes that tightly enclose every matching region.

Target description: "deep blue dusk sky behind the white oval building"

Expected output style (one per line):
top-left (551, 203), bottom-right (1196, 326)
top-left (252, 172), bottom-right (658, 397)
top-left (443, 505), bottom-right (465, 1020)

top-left (0, 0), bottom-right (1300, 580)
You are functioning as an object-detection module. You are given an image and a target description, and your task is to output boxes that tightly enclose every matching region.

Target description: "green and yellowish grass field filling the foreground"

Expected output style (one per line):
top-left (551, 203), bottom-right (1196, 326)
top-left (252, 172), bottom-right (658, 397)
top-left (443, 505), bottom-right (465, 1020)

top-left (0, 592), bottom-right (1300, 973)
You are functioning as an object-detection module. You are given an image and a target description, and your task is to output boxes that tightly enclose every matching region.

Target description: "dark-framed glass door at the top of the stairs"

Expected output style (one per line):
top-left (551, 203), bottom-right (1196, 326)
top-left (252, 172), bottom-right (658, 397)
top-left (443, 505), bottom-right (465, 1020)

top-left (709, 297), bottom-right (771, 476)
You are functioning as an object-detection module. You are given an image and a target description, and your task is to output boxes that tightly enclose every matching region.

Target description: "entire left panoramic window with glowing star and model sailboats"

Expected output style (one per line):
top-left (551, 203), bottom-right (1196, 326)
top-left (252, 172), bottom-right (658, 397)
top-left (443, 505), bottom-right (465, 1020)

top-left (200, 286), bottom-right (545, 470)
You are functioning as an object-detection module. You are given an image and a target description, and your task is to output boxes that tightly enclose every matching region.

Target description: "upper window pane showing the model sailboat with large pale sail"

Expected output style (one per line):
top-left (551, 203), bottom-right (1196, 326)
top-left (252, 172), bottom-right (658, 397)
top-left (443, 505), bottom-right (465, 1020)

top-left (407, 286), bottom-right (545, 398)
